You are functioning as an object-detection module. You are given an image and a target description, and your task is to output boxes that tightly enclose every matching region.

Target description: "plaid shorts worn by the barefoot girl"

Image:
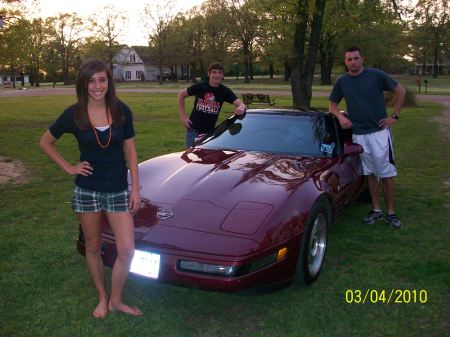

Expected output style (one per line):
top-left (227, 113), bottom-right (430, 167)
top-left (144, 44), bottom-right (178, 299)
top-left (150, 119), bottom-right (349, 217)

top-left (72, 185), bottom-right (130, 213)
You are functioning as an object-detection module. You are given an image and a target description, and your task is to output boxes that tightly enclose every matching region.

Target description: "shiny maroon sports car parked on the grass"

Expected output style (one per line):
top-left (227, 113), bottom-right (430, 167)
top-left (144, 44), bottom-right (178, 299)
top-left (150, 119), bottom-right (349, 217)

top-left (78, 108), bottom-right (365, 292)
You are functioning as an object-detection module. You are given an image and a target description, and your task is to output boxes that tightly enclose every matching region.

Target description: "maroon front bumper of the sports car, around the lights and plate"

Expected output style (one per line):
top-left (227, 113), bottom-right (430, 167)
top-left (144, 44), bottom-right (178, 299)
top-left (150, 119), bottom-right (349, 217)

top-left (77, 231), bottom-right (301, 294)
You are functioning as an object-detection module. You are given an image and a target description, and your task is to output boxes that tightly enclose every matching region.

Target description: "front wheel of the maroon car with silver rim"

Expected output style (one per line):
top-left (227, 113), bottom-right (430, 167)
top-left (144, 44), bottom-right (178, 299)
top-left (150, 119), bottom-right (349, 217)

top-left (294, 197), bottom-right (332, 286)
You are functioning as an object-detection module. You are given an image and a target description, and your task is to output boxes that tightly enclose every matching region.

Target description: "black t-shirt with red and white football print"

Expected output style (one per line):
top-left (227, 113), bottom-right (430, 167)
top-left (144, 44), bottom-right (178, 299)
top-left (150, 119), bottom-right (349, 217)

top-left (187, 82), bottom-right (237, 133)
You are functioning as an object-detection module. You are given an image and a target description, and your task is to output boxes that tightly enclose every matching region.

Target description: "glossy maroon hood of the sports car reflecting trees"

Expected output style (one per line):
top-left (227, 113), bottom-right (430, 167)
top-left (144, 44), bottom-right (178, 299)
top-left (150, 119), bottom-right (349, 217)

top-left (125, 148), bottom-right (330, 255)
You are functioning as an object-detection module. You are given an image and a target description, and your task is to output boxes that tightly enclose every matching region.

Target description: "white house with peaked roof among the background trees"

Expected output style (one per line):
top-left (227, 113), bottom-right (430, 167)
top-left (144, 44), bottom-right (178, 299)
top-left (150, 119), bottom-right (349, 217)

top-left (113, 47), bottom-right (181, 82)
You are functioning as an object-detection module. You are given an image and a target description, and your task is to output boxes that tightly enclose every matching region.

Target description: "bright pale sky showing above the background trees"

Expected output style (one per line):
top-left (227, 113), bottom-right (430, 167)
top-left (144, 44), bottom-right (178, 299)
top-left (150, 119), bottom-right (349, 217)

top-left (25, 0), bottom-right (205, 46)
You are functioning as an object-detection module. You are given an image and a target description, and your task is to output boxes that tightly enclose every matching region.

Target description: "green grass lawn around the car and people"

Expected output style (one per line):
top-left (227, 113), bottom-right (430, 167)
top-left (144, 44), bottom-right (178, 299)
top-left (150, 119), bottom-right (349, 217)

top-left (0, 93), bottom-right (450, 337)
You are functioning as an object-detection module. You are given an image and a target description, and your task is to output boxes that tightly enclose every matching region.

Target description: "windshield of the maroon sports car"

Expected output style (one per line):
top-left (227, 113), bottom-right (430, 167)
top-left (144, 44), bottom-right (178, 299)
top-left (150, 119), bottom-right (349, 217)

top-left (198, 113), bottom-right (337, 157)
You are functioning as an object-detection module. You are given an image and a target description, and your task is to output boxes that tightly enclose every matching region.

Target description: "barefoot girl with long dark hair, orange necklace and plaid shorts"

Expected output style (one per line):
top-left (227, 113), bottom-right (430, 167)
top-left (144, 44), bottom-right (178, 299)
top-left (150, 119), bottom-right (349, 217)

top-left (39, 59), bottom-right (142, 318)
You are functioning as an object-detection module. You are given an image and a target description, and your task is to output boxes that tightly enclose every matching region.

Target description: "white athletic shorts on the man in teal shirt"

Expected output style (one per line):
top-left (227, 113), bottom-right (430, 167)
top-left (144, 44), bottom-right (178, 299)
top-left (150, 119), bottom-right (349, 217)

top-left (353, 128), bottom-right (397, 178)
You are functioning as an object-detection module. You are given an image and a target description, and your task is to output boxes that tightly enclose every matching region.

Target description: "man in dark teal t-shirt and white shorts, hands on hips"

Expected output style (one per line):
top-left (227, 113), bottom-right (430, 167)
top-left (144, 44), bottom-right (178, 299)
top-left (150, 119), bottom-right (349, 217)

top-left (329, 47), bottom-right (405, 228)
